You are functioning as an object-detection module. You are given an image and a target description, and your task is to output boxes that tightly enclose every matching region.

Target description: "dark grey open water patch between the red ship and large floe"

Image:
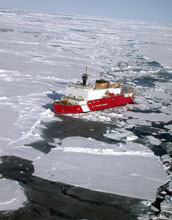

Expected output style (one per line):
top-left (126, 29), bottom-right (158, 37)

top-left (42, 116), bottom-right (117, 143)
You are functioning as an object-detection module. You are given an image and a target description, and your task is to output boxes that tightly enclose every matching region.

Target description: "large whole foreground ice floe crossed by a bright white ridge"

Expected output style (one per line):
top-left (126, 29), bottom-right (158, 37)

top-left (31, 137), bottom-right (168, 201)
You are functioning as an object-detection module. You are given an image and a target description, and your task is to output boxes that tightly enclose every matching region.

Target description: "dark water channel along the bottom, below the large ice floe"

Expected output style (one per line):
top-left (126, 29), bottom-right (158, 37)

top-left (0, 156), bottom-right (146, 220)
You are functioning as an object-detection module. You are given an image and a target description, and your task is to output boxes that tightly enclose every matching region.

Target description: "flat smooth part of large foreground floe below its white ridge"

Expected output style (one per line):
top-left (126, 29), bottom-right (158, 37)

top-left (33, 149), bottom-right (168, 202)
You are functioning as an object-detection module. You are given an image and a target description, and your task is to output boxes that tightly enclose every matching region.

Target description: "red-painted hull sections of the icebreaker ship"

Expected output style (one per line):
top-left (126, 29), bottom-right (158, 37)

top-left (53, 94), bottom-right (134, 114)
